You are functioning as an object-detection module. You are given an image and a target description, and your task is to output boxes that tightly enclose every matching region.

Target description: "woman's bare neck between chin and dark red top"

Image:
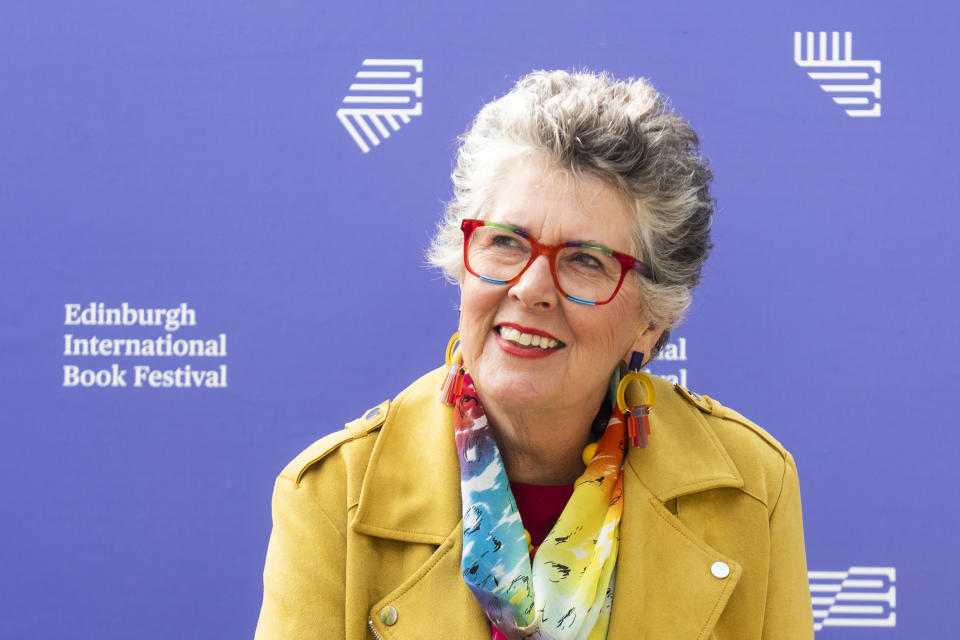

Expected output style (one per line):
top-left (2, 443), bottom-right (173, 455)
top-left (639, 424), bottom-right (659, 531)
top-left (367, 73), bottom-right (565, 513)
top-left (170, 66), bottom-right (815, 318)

top-left (478, 384), bottom-right (604, 485)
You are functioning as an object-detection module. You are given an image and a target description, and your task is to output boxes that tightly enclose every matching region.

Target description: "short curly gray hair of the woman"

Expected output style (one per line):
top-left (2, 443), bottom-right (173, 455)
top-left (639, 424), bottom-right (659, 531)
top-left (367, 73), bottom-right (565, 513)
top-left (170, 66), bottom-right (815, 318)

top-left (427, 71), bottom-right (716, 355)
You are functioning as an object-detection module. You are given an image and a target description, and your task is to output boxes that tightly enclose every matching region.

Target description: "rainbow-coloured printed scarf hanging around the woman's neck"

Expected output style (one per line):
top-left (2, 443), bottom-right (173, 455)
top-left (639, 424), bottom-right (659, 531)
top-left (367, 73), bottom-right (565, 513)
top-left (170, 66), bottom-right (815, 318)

top-left (453, 374), bottom-right (626, 640)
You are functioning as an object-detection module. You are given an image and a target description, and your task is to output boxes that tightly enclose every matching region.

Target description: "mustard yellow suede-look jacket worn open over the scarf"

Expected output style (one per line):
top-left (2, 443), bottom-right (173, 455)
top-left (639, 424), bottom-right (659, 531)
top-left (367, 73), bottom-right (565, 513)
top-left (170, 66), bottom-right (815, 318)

top-left (256, 370), bottom-right (813, 640)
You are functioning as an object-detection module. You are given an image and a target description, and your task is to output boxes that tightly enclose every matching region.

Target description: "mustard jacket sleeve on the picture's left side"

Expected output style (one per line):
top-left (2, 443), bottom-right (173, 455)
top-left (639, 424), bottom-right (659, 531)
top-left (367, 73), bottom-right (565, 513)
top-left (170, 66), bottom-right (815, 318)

top-left (256, 461), bottom-right (346, 640)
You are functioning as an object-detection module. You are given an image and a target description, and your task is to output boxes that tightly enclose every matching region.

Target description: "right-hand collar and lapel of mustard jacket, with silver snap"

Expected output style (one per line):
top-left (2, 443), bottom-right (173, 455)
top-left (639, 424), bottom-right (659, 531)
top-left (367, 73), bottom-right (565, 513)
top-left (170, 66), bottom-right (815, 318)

top-left (609, 378), bottom-right (743, 640)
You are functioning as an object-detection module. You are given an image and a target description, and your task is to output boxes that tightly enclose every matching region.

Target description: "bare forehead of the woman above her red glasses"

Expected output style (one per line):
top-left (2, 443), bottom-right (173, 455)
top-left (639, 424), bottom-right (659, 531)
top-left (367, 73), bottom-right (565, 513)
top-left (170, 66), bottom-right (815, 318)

top-left (483, 159), bottom-right (633, 252)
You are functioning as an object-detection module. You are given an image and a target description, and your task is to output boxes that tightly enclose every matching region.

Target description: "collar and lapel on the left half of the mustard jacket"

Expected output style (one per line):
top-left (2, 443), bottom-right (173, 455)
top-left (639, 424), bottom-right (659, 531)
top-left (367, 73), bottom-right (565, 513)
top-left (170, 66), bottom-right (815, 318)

top-left (352, 371), bottom-right (490, 640)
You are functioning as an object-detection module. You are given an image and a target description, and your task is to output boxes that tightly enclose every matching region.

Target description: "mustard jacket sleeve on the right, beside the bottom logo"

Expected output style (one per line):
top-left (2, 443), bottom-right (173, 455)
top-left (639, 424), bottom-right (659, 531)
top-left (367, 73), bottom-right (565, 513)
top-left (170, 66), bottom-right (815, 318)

top-left (763, 453), bottom-right (813, 640)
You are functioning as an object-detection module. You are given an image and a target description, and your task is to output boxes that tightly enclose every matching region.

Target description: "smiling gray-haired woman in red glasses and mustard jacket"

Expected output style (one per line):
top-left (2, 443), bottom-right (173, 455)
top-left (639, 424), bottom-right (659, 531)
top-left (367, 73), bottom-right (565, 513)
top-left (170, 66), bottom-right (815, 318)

top-left (257, 72), bottom-right (813, 640)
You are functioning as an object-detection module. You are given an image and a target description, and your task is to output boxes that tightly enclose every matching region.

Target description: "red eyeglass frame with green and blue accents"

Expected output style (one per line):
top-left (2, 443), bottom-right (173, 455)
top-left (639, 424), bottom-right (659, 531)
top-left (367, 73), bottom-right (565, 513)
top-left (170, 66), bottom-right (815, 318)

top-left (460, 218), bottom-right (653, 307)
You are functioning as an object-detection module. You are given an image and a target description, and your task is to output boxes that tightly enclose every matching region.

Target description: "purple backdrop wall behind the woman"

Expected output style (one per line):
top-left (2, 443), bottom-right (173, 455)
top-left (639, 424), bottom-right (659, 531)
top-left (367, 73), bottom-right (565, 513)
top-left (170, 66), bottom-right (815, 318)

top-left (0, 0), bottom-right (960, 640)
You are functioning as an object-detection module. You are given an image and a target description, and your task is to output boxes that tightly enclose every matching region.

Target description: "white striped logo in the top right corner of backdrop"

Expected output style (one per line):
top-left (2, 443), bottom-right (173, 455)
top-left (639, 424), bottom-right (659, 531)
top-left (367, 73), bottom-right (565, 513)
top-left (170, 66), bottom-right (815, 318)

top-left (793, 31), bottom-right (880, 118)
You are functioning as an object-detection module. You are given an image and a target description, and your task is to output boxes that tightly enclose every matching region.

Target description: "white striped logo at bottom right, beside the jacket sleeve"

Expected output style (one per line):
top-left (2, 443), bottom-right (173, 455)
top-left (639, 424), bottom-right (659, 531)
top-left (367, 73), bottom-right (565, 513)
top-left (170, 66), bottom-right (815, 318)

top-left (807, 567), bottom-right (897, 631)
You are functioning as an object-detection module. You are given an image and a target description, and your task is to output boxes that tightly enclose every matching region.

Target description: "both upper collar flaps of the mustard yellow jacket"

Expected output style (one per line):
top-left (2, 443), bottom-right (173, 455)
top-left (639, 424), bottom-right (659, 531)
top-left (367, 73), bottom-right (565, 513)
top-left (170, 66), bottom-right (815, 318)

top-left (353, 369), bottom-right (743, 545)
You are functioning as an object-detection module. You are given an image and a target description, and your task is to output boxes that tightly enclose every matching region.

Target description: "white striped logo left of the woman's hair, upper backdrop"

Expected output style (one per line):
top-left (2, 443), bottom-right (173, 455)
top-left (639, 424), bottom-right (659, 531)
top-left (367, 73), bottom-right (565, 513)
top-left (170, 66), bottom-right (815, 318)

top-left (337, 58), bottom-right (423, 153)
